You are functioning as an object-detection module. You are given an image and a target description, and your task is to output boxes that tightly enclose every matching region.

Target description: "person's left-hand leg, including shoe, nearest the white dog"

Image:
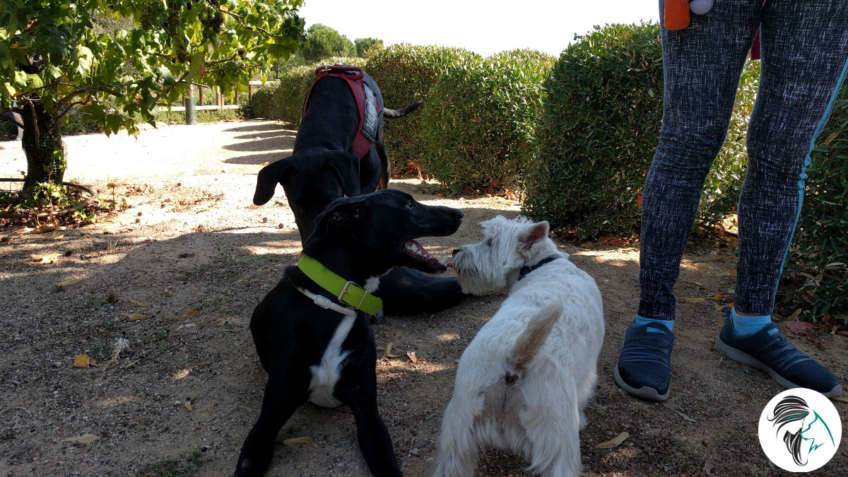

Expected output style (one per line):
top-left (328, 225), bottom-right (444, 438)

top-left (615, 0), bottom-right (761, 400)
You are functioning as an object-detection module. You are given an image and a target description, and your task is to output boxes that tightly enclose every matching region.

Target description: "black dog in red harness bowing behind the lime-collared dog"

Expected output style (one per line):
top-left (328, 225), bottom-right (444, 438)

top-left (253, 65), bottom-right (464, 314)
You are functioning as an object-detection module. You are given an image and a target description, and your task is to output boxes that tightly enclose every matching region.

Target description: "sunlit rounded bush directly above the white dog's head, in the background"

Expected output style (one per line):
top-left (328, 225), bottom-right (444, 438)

top-left (421, 50), bottom-right (555, 193)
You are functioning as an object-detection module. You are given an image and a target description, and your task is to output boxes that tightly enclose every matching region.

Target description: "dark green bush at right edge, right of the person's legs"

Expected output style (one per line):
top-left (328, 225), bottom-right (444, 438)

top-left (780, 85), bottom-right (848, 326)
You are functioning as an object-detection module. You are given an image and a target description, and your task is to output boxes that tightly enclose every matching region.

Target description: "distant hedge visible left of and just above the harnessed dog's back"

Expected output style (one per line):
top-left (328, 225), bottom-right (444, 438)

top-left (245, 57), bottom-right (365, 126)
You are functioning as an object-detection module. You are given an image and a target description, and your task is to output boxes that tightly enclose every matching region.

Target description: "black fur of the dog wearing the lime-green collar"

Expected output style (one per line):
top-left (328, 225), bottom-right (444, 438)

top-left (236, 191), bottom-right (462, 476)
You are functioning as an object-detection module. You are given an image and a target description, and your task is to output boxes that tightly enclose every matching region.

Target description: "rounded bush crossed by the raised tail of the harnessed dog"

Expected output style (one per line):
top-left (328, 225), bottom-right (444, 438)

top-left (365, 45), bottom-right (480, 176)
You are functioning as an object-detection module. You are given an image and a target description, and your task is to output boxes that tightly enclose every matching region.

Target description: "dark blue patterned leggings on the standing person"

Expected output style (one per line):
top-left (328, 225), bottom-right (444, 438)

top-left (639, 0), bottom-right (848, 319)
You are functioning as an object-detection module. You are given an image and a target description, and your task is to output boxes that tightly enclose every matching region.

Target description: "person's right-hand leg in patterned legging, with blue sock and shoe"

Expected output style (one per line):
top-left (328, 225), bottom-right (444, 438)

top-left (716, 0), bottom-right (848, 395)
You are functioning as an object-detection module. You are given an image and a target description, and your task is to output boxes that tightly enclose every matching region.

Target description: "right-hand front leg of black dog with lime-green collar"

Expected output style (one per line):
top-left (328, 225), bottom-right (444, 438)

top-left (336, 344), bottom-right (403, 477)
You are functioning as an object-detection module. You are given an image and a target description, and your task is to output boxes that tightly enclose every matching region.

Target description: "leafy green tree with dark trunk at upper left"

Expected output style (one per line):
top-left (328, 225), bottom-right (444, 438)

top-left (0, 0), bottom-right (303, 193)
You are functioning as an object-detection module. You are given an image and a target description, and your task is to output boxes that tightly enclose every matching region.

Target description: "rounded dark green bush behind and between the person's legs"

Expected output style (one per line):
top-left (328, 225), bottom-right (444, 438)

top-left (524, 25), bottom-right (759, 238)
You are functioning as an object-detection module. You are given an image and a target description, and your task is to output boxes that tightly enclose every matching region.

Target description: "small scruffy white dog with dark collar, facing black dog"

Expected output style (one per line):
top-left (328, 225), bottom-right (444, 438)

top-left (436, 216), bottom-right (604, 477)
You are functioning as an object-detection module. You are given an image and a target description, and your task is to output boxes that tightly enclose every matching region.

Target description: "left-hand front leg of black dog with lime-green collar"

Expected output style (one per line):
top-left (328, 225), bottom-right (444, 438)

top-left (235, 373), bottom-right (309, 477)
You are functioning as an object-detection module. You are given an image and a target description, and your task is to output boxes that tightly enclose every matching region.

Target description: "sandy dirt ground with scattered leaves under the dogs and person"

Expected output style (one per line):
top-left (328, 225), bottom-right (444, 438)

top-left (0, 121), bottom-right (848, 477)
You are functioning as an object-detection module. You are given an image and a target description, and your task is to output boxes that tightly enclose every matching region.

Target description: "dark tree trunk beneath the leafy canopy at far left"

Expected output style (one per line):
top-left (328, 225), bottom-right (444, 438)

top-left (21, 100), bottom-right (67, 197)
